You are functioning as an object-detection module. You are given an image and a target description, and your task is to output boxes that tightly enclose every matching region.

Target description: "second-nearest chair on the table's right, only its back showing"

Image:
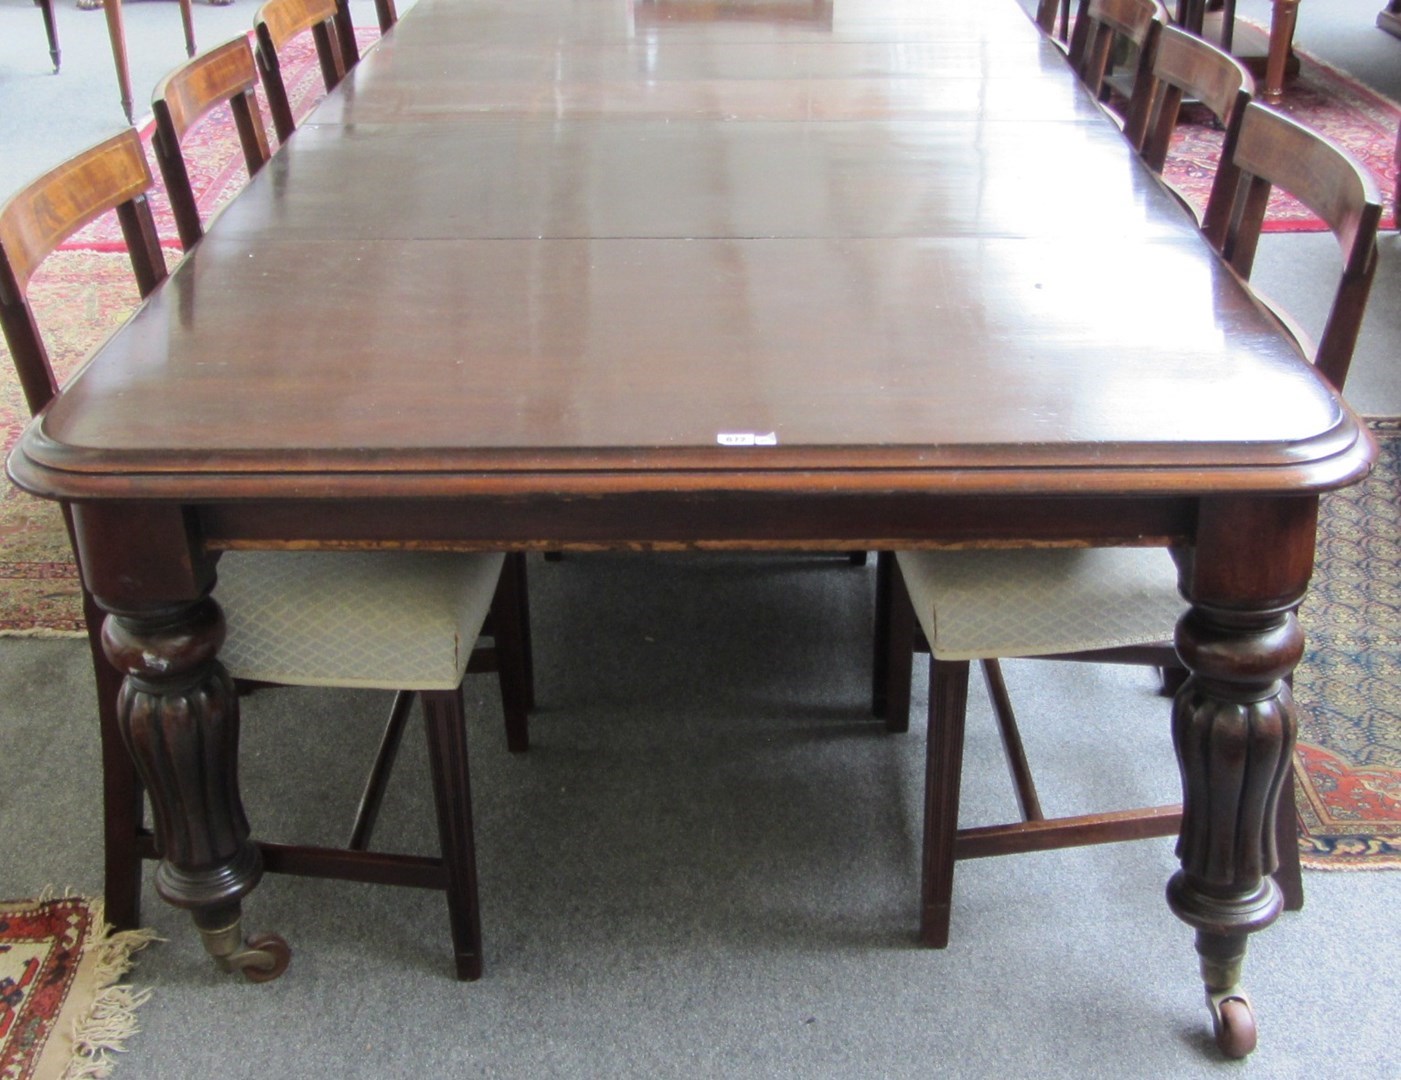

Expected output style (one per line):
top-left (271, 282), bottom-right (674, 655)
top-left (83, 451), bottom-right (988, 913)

top-left (1124, 27), bottom-right (1255, 216)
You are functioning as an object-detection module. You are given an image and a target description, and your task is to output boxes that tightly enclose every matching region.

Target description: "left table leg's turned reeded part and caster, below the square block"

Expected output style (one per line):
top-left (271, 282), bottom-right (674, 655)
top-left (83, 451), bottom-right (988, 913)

top-left (102, 597), bottom-right (290, 982)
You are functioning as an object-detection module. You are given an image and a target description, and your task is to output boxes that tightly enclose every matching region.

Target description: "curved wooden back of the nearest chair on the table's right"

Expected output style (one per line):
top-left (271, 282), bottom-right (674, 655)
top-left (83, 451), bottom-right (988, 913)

top-left (1202, 101), bottom-right (1381, 391)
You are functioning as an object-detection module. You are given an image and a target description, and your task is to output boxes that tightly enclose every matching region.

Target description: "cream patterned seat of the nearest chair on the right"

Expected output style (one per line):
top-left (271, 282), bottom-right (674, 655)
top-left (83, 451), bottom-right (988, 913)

top-left (897, 548), bottom-right (1187, 660)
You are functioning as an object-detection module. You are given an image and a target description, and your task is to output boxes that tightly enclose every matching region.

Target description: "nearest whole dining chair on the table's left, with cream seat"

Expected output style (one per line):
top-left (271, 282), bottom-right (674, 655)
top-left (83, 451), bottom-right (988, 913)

top-left (0, 129), bottom-right (531, 982)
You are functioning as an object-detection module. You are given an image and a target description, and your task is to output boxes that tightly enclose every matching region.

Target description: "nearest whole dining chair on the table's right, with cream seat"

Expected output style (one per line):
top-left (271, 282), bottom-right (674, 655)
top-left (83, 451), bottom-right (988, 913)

top-left (878, 102), bottom-right (1381, 948)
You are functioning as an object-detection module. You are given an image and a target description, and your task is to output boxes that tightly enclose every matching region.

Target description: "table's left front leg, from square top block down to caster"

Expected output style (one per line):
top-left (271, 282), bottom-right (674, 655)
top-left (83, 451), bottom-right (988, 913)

top-left (73, 504), bottom-right (290, 982)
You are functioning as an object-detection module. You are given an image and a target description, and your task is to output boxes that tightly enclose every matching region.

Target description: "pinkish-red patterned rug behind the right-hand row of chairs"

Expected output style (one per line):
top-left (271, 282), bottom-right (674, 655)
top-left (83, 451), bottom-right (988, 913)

top-left (1163, 29), bottom-right (1401, 233)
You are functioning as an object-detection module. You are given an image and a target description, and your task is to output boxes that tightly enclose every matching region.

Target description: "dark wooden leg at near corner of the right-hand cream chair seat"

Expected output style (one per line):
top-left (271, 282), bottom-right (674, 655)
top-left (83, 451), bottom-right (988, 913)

top-left (919, 660), bottom-right (968, 948)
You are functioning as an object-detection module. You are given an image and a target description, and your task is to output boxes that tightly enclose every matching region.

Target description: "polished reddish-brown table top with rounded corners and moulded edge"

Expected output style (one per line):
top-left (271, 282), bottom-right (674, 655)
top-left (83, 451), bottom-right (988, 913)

top-left (14, 0), bottom-right (1356, 501)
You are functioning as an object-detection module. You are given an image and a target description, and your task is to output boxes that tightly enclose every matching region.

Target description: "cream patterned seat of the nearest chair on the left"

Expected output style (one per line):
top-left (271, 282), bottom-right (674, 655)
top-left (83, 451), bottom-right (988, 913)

top-left (214, 552), bottom-right (504, 691)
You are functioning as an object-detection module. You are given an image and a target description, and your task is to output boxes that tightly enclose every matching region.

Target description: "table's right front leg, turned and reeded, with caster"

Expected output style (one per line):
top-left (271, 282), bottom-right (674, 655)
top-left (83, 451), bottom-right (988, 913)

top-left (1167, 499), bottom-right (1317, 1058)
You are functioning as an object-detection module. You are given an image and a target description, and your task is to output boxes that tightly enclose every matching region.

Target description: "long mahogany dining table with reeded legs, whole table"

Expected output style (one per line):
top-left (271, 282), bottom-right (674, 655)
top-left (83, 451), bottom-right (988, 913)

top-left (8, 0), bottom-right (1376, 1053)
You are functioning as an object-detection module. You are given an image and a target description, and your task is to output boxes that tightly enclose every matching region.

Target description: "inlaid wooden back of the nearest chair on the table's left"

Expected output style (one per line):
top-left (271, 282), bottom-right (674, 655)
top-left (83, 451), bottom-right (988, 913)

top-left (0, 129), bottom-right (165, 413)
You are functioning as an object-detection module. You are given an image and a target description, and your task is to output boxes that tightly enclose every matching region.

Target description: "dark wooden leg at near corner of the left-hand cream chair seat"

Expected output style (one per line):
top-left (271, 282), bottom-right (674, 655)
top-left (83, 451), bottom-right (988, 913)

top-left (419, 689), bottom-right (482, 982)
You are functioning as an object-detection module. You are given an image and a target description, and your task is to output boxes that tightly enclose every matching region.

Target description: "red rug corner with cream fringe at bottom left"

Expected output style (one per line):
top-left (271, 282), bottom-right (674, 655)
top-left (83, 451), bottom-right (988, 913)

top-left (0, 896), bottom-right (154, 1080)
